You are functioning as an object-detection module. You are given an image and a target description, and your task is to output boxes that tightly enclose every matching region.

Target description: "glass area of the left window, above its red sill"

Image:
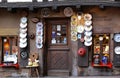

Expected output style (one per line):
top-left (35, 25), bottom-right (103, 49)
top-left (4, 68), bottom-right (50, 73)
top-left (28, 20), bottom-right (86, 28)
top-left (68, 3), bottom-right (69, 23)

top-left (2, 37), bottom-right (18, 64)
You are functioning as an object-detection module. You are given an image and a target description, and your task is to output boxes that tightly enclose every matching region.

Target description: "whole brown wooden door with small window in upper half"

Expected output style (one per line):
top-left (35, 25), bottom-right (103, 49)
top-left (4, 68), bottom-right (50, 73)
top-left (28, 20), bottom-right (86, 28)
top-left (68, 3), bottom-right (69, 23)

top-left (46, 19), bottom-right (69, 76)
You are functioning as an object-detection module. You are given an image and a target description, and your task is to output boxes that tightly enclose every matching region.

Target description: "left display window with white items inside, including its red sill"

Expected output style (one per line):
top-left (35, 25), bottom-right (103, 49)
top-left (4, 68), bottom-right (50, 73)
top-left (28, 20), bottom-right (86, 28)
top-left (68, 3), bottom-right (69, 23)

top-left (0, 36), bottom-right (18, 67)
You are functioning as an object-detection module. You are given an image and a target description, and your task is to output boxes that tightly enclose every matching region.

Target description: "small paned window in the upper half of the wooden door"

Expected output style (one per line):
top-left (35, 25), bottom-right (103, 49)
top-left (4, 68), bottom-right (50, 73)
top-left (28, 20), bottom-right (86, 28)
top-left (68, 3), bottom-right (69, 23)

top-left (51, 25), bottom-right (67, 44)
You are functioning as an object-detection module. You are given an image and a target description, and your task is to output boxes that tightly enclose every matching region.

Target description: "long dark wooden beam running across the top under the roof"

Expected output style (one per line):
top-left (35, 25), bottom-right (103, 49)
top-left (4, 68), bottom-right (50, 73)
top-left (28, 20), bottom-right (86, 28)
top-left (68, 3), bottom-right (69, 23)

top-left (0, 1), bottom-right (120, 8)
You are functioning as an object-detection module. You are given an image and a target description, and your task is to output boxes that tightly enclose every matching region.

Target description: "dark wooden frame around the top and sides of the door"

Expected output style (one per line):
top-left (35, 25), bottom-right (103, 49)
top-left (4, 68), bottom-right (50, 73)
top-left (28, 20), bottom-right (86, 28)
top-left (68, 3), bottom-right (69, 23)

top-left (43, 17), bottom-right (72, 76)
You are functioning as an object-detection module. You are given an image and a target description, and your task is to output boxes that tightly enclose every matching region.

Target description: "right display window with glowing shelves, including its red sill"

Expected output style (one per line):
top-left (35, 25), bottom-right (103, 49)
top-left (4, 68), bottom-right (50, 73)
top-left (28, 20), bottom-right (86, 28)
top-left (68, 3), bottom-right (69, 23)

top-left (92, 34), bottom-right (112, 68)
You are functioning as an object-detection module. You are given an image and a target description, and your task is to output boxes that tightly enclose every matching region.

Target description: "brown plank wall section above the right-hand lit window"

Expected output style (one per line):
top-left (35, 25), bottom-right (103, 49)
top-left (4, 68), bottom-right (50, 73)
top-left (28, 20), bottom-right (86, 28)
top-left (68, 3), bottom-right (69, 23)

top-left (84, 7), bottom-right (120, 33)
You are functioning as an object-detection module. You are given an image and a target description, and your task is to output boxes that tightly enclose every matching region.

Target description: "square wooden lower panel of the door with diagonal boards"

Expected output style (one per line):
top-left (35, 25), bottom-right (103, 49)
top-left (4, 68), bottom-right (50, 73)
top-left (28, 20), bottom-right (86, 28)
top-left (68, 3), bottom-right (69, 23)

top-left (48, 51), bottom-right (69, 70)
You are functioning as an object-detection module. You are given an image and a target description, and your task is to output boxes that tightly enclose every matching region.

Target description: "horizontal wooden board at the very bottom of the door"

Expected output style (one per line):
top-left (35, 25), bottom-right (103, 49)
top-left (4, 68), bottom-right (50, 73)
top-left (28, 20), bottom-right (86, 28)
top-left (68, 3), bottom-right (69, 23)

top-left (48, 70), bottom-right (69, 76)
